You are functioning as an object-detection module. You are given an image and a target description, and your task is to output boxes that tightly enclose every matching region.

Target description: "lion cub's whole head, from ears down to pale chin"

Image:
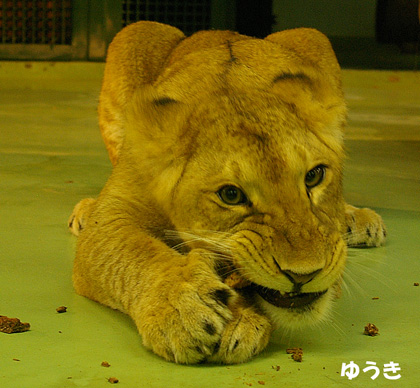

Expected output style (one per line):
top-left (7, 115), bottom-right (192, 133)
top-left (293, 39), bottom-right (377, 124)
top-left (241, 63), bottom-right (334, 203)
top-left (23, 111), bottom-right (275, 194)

top-left (121, 30), bottom-right (346, 325)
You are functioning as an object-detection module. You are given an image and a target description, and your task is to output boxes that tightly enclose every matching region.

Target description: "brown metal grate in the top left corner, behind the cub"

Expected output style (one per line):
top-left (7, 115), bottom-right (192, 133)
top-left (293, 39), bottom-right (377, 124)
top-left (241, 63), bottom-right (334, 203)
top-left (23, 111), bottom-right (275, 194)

top-left (0, 0), bottom-right (72, 45)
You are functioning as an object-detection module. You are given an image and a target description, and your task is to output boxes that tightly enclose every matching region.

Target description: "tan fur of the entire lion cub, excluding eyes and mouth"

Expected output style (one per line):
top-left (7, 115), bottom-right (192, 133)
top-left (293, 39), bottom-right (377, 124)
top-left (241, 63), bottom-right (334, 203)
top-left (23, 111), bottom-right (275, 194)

top-left (70, 22), bottom-right (385, 363)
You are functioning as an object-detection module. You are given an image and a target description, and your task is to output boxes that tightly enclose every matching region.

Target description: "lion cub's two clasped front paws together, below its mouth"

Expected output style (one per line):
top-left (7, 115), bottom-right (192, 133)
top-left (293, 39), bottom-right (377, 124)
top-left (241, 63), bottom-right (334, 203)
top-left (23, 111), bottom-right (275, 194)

top-left (136, 253), bottom-right (270, 364)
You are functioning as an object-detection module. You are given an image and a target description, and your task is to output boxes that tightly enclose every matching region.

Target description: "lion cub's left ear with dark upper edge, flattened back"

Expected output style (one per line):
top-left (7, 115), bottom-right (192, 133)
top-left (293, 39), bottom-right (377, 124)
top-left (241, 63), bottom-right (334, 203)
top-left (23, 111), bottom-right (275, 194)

top-left (124, 86), bottom-right (187, 158)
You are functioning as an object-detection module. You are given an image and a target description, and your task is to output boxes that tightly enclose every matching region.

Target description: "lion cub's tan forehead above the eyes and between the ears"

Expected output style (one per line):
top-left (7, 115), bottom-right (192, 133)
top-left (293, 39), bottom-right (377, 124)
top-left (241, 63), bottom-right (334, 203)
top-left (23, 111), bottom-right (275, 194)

top-left (191, 90), bottom-right (341, 184)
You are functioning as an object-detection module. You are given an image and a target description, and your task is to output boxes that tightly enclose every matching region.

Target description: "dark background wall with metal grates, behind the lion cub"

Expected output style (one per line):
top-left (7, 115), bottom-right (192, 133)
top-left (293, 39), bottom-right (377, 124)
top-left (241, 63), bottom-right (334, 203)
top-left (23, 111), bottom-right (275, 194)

top-left (0, 0), bottom-right (420, 69)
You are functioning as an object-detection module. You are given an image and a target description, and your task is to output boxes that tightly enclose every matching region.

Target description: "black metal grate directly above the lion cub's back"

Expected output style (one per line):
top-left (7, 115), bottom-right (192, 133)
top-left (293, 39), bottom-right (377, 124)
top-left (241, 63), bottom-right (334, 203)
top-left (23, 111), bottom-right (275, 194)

top-left (122, 0), bottom-right (211, 35)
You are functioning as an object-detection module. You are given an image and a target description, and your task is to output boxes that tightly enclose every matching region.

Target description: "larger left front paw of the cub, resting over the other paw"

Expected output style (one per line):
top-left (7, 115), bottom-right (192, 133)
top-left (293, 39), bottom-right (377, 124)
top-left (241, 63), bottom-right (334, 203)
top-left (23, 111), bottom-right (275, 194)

top-left (138, 282), bottom-right (233, 364)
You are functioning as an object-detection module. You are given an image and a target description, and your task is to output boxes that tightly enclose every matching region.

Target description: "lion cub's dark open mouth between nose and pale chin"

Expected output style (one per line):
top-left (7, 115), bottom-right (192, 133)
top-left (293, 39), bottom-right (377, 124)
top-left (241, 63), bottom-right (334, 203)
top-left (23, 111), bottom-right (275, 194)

top-left (255, 285), bottom-right (327, 309)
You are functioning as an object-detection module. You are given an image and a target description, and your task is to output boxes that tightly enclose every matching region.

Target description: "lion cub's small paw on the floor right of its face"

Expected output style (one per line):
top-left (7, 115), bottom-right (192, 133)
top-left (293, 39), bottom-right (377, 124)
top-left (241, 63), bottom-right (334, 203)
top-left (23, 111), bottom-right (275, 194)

top-left (345, 204), bottom-right (386, 247)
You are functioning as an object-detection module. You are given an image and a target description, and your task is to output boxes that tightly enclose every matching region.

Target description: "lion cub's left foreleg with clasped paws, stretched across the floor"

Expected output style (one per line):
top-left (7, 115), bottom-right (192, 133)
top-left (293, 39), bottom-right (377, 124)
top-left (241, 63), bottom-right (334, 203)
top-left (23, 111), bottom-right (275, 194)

top-left (73, 206), bottom-right (271, 364)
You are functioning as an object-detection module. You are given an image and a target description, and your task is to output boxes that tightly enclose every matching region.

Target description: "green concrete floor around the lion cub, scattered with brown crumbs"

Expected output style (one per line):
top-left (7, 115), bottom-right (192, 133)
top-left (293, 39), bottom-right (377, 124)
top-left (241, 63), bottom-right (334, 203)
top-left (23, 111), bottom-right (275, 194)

top-left (0, 62), bottom-right (420, 388)
